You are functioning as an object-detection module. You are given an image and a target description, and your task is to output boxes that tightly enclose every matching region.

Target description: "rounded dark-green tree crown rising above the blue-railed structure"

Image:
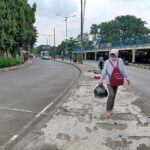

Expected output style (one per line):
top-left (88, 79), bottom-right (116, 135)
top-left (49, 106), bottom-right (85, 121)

top-left (90, 15), bottom-right (150, 43)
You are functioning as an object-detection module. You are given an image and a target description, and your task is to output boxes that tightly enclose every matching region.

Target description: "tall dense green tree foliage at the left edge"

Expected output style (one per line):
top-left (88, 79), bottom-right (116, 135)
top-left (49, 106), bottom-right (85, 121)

top-left (0, 0), bottom-right (37, 56)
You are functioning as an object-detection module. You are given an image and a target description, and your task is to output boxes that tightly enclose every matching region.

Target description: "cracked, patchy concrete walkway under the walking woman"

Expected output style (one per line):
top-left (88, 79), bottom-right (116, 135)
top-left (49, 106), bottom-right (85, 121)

top-left (15, 59), bottom-right (150, 150)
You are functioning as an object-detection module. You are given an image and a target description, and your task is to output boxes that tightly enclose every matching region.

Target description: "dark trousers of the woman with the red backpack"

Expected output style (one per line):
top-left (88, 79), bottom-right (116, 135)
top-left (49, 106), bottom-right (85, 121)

top-left (106, 84), bottom-right (118, 111)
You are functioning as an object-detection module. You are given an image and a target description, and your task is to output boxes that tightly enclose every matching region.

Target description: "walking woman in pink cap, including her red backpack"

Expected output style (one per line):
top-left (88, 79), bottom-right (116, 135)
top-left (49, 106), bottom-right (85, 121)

top-left (99, 49), bottom-right (130, 117)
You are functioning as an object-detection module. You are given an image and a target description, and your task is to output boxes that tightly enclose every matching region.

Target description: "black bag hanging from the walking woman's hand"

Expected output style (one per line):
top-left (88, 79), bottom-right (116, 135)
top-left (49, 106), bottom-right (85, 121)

top-left (94, 85), bottom-right (108, 98)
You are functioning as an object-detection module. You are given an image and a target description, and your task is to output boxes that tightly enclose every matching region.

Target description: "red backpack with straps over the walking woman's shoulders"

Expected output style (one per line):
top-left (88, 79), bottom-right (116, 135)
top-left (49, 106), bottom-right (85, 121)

top-left (109, 59), bottom-right (124, 86)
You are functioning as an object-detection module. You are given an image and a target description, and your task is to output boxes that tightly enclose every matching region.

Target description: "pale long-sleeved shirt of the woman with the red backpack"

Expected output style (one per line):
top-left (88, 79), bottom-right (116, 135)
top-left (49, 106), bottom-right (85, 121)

top-left (100, 58), bottom-right (128, 84)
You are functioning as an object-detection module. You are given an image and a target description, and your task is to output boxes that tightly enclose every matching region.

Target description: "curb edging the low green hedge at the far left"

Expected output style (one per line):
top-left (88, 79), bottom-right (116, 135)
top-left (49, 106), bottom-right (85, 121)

top-left (0, 59), bottom-right (33, 73)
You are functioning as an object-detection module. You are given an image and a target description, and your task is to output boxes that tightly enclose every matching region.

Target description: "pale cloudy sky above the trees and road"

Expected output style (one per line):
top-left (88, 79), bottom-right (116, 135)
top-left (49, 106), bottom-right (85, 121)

top-left (28, 0), bottom-right (150, 46)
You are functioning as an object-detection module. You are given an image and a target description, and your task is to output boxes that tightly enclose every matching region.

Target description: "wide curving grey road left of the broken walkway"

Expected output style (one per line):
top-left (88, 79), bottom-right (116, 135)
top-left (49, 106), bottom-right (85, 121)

top-left (0, 59), bottom-right (79, 146)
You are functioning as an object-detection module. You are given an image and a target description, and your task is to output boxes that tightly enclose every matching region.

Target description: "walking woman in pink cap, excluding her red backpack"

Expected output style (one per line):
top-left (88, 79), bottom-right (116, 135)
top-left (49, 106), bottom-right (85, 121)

top-left (99, 49), bottom-right (130, 117)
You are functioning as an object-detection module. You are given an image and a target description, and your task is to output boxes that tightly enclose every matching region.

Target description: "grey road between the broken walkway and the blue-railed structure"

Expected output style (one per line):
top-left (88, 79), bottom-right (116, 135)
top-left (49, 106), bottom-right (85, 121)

top-left (84, 61), bottom-right (150, 107)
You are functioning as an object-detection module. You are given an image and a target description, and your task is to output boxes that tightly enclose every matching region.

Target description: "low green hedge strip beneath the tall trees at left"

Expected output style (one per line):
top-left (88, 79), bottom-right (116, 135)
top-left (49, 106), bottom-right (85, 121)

top-left (0, 57), bottom-right (24, 68)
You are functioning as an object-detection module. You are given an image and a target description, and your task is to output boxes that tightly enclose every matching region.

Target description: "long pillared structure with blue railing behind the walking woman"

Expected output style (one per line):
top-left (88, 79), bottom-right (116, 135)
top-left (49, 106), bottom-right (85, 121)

top-left (73, 36), bottom-right (150, 63)
